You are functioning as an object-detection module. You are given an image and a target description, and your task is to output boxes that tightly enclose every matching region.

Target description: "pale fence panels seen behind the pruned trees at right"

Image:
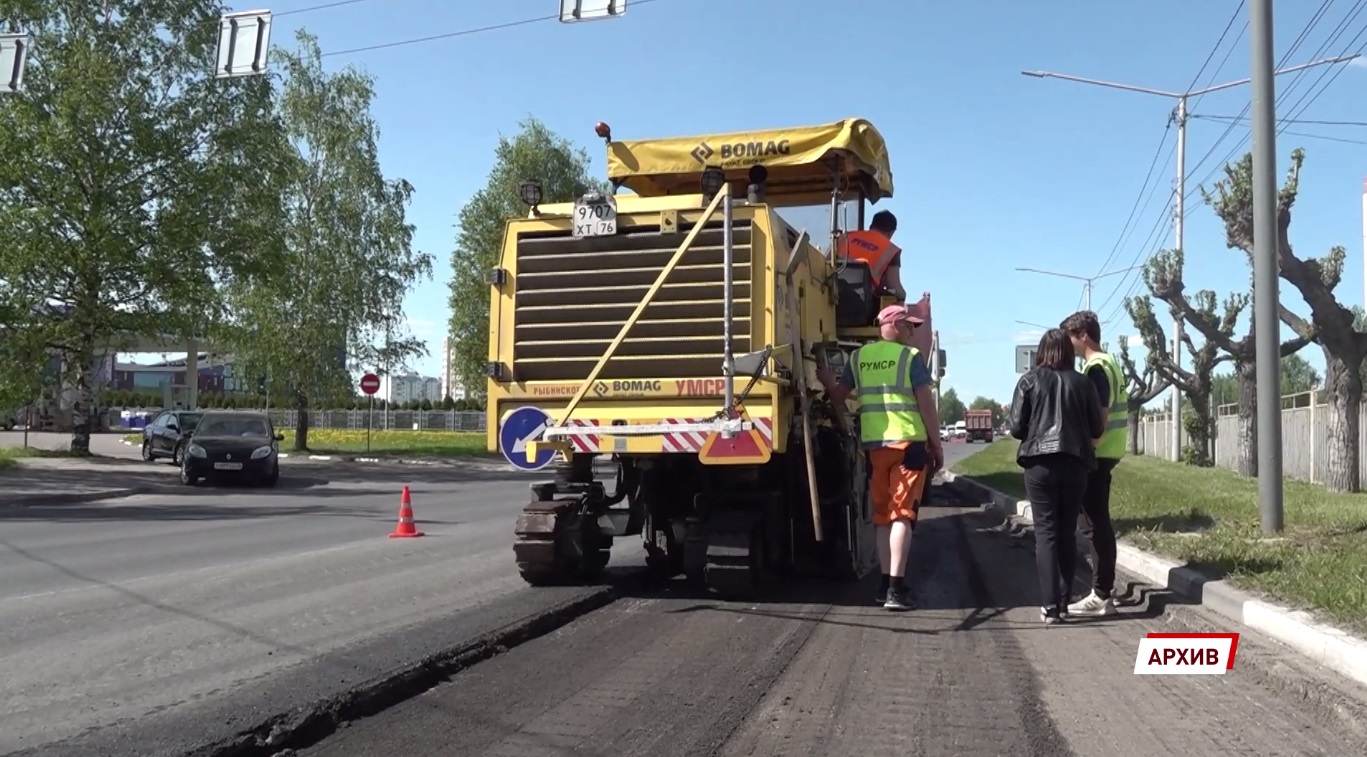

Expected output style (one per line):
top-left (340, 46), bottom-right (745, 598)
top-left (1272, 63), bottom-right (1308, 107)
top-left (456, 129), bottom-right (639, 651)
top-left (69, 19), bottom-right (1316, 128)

top-left (1139, 392), bottom-right (1367, 482)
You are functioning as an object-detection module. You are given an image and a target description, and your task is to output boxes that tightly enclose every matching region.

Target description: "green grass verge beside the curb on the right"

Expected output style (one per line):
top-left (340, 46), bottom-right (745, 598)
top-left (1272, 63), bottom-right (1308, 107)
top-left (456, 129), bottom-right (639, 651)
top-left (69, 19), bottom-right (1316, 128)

top-left (954, 439), bottom-right (1367, 631)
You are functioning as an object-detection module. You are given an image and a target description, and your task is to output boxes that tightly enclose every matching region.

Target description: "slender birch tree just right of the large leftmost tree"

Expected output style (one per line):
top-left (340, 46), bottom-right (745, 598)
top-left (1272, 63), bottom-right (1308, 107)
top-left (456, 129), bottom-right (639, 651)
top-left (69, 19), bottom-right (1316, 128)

top-left (220, 30), bottom-right (432, 450)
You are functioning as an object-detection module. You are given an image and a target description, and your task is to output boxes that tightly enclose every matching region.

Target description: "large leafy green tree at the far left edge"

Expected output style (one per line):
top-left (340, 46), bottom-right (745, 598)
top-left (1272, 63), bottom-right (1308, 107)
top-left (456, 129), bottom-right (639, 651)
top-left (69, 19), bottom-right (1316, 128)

top-left (0, 0), bottom-right (288, 454)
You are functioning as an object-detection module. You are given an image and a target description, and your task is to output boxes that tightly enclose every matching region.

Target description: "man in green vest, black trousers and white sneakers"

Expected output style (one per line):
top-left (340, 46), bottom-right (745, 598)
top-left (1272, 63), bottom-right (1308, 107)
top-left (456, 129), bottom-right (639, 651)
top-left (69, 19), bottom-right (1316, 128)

top-left (1059, 310), bottom-right (1129, 616)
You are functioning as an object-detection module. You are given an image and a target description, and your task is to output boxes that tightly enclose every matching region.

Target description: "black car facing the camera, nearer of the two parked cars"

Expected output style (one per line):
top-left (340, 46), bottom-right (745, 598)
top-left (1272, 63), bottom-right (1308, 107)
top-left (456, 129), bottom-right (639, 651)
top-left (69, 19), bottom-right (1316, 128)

top-left (180, 410), bottom-right (284, 486)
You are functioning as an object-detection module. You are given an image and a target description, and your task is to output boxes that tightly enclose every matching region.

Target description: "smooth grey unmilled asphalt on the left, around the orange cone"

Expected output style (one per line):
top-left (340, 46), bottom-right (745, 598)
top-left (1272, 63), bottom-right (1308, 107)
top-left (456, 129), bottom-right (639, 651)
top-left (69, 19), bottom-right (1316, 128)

top-left (0, 466), bottom-right (642, 757)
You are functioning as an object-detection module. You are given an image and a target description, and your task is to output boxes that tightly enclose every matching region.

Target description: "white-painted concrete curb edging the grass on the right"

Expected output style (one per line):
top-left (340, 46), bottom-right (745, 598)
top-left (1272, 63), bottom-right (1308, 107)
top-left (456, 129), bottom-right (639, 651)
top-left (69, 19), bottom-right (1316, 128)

top-left (945, 471), bottom-right (1367, 686)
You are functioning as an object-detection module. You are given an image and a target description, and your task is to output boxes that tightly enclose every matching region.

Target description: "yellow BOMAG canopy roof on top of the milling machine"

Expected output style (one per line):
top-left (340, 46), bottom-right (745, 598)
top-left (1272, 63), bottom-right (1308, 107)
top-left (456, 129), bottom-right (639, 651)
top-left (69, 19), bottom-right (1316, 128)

top-left (607, 119), bottom-right (893, 204)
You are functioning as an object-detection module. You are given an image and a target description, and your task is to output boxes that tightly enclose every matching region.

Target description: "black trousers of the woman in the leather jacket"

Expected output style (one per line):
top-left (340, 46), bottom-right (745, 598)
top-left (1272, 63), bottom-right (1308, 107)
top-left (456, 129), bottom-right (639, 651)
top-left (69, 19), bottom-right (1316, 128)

top-left (1023, 455), bottom-right (1088, 609)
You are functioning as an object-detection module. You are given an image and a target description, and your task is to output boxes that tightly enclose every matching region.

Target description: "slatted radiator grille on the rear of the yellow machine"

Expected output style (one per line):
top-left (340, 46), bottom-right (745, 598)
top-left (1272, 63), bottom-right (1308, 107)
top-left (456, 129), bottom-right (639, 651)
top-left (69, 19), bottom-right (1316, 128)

top-left (513, 220), bottom-right (763, 381)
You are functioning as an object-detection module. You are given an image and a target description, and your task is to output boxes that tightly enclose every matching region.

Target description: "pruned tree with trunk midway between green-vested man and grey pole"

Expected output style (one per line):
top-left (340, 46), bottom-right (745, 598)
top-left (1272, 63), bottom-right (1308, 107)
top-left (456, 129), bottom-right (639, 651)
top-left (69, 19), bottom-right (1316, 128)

top-left (1125, 285), bottom-right (1248, 466)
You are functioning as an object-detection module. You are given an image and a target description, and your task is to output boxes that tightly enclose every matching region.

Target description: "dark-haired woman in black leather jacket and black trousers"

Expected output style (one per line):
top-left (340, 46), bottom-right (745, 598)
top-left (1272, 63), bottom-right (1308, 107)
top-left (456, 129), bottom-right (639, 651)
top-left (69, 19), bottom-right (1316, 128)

top-left (1012, 328), bottom-right (1106, 623)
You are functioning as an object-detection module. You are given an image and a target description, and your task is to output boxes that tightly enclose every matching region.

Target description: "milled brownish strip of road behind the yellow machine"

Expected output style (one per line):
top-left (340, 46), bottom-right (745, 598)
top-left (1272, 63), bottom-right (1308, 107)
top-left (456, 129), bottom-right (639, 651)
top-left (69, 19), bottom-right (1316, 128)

top-left (301, 489), bottom-right (1367, 757)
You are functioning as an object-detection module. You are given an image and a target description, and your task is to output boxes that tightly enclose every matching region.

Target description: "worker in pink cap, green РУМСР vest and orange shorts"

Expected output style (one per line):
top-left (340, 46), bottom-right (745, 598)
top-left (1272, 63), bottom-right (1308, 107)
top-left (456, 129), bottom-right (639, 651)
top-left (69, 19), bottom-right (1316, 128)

top-left (816, 305), bottom-right (945, 611)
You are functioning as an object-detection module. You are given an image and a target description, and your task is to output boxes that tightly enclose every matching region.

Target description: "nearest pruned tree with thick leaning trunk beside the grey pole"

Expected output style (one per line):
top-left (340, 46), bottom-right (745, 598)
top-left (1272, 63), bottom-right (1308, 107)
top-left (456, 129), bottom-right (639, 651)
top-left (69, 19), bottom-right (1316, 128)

top-left (1206, 148), bottom-right (1367, 492)
